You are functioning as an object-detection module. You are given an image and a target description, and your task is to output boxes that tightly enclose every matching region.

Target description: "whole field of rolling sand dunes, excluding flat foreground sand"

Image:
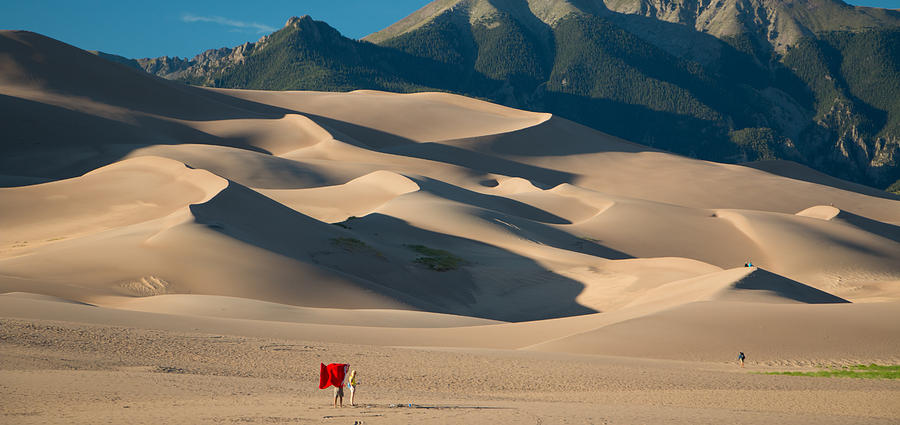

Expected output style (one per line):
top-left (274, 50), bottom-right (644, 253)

top-left (0, 31), bottom-right (900, 396)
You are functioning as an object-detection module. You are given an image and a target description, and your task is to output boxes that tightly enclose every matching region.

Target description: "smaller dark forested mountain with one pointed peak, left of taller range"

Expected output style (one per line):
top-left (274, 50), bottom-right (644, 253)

top-left (123, 16), bottom-right (474, 92)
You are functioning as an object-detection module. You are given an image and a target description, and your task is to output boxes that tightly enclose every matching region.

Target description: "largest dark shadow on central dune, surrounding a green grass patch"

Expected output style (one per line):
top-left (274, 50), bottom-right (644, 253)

top-left (190, 182), bottom-right (596, 321)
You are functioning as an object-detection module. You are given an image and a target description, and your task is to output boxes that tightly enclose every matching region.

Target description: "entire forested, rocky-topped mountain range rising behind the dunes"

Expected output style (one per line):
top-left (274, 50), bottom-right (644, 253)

top-left (125, 0), bottom-right (900, 188)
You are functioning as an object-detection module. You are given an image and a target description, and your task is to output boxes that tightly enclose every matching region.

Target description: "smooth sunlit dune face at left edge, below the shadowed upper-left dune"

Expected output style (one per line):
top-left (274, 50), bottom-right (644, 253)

top-left (0, 157), bottom-right (226, 256)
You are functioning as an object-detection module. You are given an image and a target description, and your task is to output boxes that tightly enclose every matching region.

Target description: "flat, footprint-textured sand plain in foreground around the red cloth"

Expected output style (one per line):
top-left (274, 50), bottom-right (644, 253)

top-left (0, 319), bottom-right (900, 424)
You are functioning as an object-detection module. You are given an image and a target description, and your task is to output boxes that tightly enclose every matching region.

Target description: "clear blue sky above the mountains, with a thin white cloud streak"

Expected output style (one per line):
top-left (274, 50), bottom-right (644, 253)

top-left (0, 0), bottom-right (900, 58)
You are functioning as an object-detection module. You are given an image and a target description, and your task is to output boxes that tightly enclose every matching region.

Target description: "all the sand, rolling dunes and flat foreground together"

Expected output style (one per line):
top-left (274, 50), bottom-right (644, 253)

top-left (0, 31), bottom-right (900, 423)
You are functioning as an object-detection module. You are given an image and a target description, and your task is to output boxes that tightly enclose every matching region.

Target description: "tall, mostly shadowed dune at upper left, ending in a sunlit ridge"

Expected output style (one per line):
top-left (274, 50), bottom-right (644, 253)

top-left (0, 31), bottom-right (348, 179)
